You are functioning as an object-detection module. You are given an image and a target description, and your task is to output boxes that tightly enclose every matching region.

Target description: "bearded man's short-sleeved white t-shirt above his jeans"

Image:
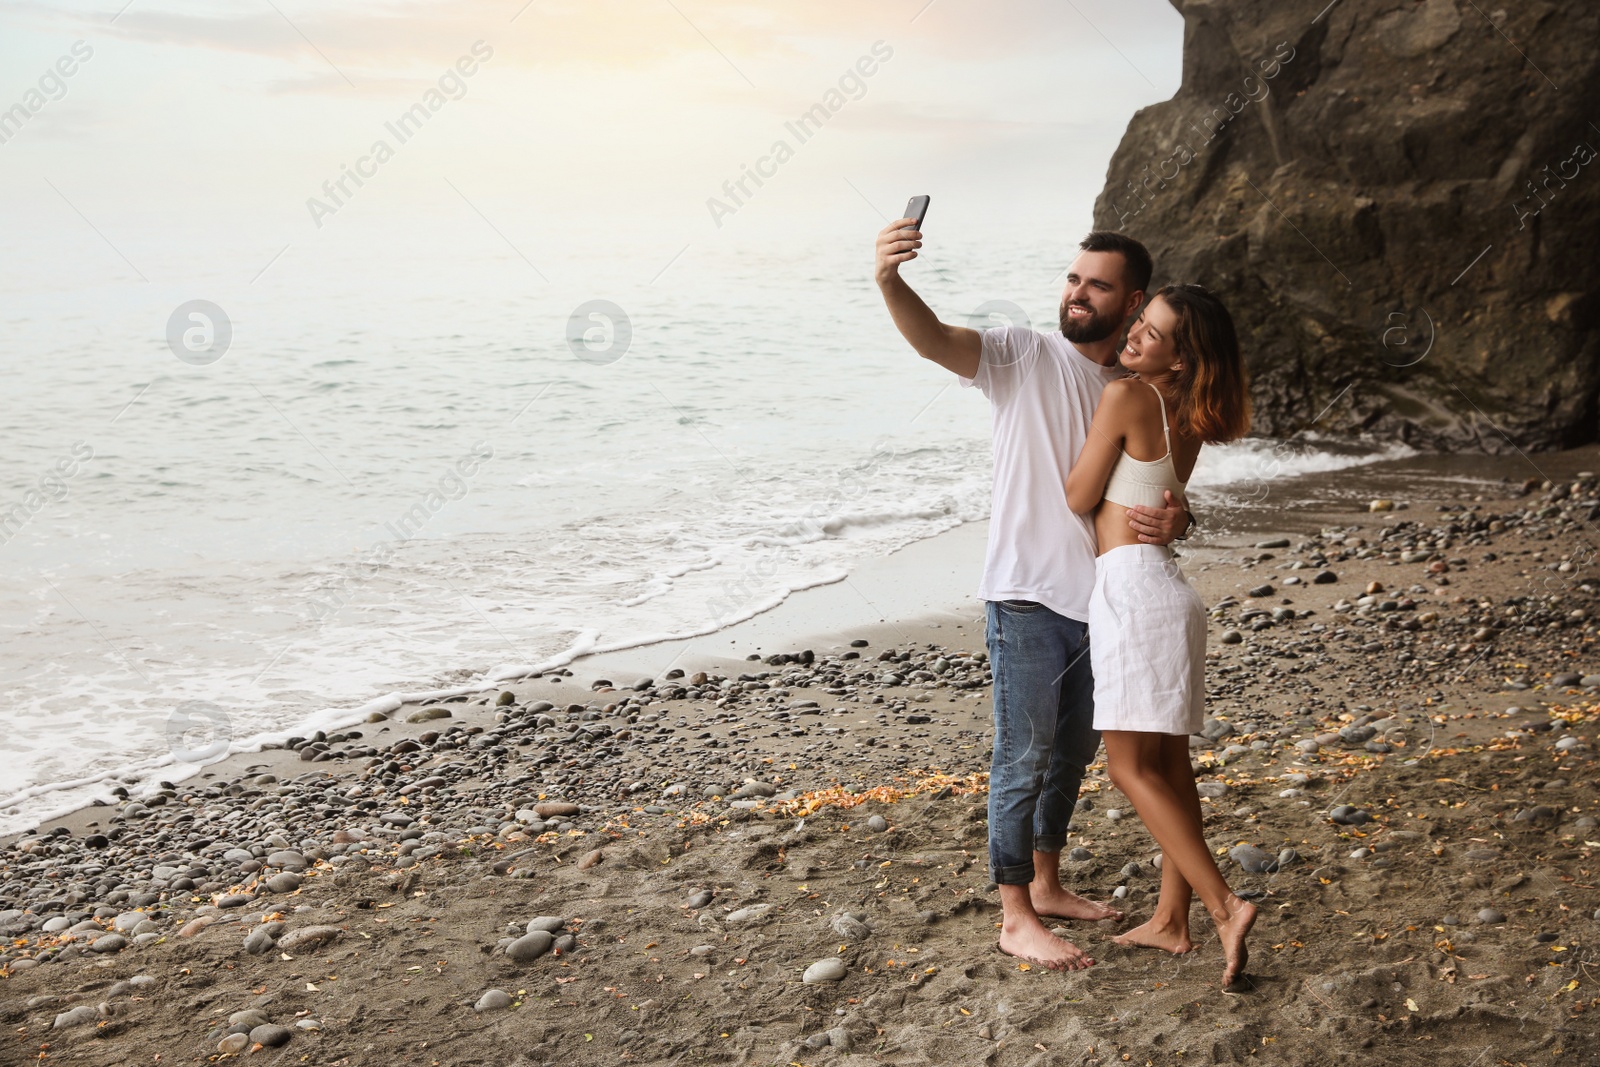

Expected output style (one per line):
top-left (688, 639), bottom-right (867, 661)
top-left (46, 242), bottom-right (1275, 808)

top-left (962, 326), bottom-right (1126, 622)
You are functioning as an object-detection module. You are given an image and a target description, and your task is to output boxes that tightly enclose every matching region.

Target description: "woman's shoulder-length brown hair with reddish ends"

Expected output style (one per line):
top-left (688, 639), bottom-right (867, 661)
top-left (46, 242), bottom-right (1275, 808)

top-left (1150, 285), bottom-right (1250, 445)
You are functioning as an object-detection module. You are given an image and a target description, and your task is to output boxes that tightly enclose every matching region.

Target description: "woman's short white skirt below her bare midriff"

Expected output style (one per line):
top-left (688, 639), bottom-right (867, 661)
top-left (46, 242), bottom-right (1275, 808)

top-left (1090, 544), bottom-right (1205, 734)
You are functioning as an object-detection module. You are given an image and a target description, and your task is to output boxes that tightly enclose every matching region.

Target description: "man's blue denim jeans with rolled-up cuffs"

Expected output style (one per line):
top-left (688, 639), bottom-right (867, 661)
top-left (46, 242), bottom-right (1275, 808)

top-left (984, 600), bottom-right (1099, 885)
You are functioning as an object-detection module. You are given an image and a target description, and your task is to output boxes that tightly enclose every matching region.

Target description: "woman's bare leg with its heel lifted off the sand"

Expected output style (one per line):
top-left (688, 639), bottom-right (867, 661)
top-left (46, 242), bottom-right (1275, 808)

top-left (1102, 729), bottom-right (1256, 985)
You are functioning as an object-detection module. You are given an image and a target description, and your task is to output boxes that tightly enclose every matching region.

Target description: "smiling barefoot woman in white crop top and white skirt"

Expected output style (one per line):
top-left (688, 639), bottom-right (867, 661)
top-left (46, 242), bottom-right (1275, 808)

top-left (1067, 285), bottom-right (1256, 989)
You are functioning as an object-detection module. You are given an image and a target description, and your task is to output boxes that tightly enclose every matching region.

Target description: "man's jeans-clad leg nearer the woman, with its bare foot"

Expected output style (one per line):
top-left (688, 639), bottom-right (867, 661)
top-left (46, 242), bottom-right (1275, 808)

top-left (1030, 616), bottom-right (1122, 921)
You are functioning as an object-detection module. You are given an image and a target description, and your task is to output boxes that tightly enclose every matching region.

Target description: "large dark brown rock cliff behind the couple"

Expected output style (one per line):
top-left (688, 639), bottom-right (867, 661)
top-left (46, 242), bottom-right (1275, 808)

top-left (1094, 0), bottom-right (1600, 451)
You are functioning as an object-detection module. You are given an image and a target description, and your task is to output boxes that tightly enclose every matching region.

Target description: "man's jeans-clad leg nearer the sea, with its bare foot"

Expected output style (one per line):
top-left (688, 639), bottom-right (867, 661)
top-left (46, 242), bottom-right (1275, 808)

top-left (986, 601), bottom-right (1093, 969)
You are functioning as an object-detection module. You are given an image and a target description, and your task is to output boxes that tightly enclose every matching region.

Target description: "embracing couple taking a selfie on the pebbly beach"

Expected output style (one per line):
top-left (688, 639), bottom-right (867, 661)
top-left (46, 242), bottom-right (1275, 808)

top-left (875, 219), bottom-right (1256, 987)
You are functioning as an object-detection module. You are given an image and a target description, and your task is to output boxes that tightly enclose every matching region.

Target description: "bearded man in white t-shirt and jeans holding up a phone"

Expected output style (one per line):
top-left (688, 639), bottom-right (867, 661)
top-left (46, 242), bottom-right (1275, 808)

top-left (875, 219), bottom-right (1190, 969)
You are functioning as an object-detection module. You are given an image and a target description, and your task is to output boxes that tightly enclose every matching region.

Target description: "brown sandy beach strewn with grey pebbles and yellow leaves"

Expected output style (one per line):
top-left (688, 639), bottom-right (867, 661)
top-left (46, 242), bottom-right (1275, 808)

top-left (0, 448), bottom-right (1600, 1067)
